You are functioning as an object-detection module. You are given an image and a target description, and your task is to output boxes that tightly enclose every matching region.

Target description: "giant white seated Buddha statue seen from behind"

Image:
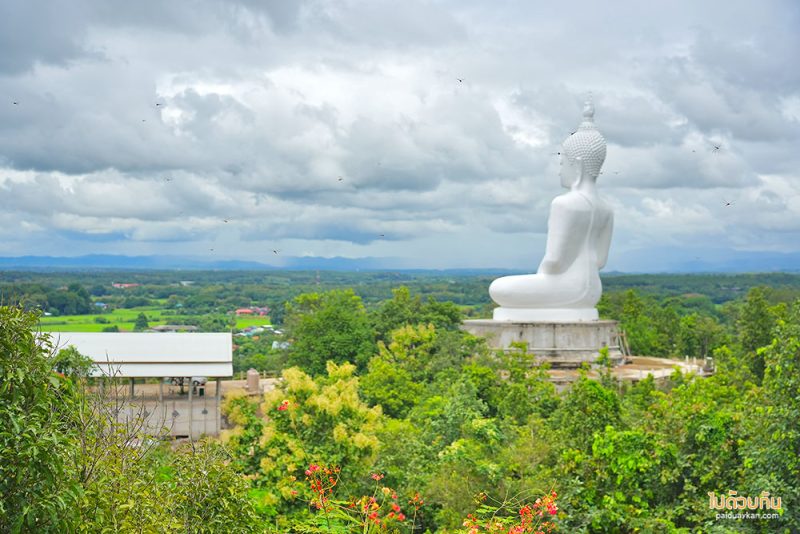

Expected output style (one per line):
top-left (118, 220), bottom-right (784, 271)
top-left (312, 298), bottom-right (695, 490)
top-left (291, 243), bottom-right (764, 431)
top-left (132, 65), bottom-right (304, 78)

top-left (489, 102), bottom-right (614, 322)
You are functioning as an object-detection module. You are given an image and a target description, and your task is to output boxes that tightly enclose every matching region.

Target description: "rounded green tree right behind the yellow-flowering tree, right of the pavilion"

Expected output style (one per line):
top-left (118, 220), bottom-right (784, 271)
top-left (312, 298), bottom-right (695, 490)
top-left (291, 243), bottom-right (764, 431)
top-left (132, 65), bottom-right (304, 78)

top-left (286, 289), bottom-right (375, 375)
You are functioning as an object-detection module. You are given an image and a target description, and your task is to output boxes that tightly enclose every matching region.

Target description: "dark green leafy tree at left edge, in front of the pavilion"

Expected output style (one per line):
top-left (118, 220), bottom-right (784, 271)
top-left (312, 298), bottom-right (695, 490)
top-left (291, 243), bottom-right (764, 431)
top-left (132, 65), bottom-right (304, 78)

top-left (0, 306), bottom-right (78, 532)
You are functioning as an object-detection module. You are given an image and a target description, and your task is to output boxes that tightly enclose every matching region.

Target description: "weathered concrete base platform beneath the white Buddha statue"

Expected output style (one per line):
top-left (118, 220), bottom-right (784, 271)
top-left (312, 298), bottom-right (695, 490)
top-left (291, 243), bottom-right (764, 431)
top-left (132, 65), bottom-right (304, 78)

top-left (461, 320), bottom-right (624, 368)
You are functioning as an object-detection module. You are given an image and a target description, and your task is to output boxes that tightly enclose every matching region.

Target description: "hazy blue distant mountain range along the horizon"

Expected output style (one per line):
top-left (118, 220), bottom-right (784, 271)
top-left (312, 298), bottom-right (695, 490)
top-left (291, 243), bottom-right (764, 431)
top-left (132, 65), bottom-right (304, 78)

top-left (0, 248), bottom-right (800, 275)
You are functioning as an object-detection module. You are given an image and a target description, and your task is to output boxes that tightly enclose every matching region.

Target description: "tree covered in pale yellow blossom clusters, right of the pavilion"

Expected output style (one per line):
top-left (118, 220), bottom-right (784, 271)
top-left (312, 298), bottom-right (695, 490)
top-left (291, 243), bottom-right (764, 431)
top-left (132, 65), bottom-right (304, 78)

top-left (223, 362), bottom-right (382, 520)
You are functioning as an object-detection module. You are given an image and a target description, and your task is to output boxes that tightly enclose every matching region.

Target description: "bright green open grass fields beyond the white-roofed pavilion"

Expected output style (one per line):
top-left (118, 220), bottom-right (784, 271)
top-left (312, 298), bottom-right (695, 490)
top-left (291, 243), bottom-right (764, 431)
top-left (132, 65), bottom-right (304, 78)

top-left (39, 307), bottom-right (270, 332)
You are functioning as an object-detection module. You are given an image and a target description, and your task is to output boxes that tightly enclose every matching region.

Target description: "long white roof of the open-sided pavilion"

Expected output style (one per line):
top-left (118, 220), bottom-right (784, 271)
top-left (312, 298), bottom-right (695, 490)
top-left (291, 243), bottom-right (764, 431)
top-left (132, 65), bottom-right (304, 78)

top-left (50, 332), bottom-right (233, 378)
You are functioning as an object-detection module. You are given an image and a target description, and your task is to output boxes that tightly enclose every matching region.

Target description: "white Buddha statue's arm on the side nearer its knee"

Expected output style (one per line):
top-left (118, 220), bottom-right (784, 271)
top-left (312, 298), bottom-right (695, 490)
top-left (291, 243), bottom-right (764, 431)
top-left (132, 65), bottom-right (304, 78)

top-left (537, 198), bottom-right (586, 274)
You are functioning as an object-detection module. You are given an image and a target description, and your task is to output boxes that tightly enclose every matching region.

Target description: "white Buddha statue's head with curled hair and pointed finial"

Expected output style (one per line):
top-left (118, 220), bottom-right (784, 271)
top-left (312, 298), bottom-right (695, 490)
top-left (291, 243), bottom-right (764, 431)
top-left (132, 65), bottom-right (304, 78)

top-left (559, 100), bottom-right (606, 188)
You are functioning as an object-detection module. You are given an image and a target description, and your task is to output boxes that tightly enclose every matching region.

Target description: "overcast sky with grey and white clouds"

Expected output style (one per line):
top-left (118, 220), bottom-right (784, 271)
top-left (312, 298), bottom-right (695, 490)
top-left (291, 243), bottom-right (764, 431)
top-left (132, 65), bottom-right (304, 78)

top-left (0, 0), bottom-right (800, 271)
